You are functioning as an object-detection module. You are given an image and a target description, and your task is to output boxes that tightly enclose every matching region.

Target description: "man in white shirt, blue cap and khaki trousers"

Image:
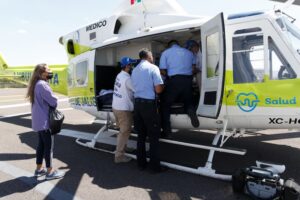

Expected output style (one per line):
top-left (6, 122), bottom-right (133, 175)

top-left (112, 57), bottom-right (136, 163)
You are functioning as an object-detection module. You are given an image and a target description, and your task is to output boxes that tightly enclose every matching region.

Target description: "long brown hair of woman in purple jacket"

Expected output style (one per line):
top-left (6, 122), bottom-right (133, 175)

top-left (26, 63), bottom-right (47, 104)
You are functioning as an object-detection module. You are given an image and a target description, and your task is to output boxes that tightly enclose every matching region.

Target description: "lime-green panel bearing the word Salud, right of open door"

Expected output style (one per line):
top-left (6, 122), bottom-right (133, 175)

top-left (223, 71), bottom-right (300, 107)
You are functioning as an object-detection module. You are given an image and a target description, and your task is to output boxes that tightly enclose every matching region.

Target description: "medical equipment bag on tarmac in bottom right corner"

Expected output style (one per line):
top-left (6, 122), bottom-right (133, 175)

top-left (232, 161), bottom-right (300, 200)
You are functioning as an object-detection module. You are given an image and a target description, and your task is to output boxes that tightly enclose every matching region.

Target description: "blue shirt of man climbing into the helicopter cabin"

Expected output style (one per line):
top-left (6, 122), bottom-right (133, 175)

top-left (159, 44), bottom-right (196, 76)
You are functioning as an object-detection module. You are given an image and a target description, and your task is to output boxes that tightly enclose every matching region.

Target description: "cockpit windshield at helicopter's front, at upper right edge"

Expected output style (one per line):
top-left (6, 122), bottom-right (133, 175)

top-left (276, 16), bottom-right (300, 55)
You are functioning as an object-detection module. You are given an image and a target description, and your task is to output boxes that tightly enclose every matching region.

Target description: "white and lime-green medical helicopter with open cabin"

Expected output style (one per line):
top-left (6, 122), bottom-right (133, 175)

top-left (60, 0), bottom-right (300, 180)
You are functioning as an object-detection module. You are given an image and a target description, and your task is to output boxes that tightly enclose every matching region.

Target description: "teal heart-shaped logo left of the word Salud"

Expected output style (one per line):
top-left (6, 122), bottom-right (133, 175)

top-left (236, 92), bottom-right (259, 112)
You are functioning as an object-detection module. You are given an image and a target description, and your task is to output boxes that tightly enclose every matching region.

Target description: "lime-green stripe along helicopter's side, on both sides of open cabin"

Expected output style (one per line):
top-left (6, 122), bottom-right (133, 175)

top-left (68, 71), bottom-right (300, 112)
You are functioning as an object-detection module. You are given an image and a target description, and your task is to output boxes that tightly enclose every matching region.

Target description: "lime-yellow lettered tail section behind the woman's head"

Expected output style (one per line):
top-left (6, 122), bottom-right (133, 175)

top-left (0, 54), bottom-right (68, 95)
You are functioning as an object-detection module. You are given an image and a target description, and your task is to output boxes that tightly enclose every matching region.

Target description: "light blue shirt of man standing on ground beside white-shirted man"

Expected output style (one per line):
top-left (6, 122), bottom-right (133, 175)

top-left (131, 60), bottom-right (163, 99)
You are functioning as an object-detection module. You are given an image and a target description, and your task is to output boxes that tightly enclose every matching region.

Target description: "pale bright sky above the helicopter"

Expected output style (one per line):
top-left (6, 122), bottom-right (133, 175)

top-left (0, 0), bottom-right (300, 66)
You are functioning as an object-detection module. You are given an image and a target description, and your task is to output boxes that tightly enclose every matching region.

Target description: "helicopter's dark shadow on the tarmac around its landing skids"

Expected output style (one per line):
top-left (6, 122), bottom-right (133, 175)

top-left (0, 113), bottom-right (300, 200)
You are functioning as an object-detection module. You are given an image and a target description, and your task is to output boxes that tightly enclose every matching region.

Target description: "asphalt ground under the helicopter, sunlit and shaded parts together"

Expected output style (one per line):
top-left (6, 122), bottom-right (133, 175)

top-left (0, 89), bottom-right (300, 200)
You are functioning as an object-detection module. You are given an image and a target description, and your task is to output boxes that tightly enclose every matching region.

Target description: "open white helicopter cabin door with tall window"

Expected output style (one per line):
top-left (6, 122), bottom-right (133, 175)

top-left (197, 13), bottom-right (225, 118)
